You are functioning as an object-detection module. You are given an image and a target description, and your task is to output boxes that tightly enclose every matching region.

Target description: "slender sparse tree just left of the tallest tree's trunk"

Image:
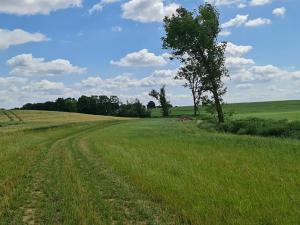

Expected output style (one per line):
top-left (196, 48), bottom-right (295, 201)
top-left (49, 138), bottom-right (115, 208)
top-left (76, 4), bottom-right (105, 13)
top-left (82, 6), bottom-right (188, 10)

top-left (175, 60), bottom-right (204, 117)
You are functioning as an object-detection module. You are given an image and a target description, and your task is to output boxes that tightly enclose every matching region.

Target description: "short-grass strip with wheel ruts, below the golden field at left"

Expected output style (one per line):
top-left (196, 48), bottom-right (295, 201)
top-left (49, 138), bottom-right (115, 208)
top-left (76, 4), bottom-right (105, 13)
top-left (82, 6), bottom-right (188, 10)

top-left (0, 121), bottom-right (180, 225)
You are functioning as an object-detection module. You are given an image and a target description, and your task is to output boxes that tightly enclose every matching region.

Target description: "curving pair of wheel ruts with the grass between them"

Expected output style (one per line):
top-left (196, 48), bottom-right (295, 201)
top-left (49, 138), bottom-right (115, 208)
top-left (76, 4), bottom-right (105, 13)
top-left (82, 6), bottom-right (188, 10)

top-left (21, 121), bottom-right (181, 225)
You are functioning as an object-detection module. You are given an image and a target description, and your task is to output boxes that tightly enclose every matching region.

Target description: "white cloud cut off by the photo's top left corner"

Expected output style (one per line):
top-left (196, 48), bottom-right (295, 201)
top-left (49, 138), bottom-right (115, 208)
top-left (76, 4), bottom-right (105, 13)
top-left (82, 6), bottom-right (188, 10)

top-left (0, 0), bottom-right (82, 15)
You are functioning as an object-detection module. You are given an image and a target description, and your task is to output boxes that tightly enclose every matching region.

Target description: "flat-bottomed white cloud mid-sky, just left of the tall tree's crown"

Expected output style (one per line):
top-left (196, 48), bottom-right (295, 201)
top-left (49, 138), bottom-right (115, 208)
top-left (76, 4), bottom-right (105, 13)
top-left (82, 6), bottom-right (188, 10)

top-left (111, 49), bottom-right (167, 67)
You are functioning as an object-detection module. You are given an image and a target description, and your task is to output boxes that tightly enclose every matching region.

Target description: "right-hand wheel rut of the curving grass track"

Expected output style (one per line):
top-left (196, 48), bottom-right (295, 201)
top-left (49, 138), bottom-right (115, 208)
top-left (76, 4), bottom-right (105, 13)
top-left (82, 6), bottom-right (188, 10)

top-left (72, 124), bottom-right (181, 225)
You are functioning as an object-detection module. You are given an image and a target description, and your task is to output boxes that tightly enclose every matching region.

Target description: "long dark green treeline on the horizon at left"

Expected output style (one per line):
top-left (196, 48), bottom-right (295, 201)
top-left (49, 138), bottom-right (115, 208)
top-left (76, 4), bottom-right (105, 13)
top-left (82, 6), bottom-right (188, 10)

top-left (21, 95), bottom-right (150, 117)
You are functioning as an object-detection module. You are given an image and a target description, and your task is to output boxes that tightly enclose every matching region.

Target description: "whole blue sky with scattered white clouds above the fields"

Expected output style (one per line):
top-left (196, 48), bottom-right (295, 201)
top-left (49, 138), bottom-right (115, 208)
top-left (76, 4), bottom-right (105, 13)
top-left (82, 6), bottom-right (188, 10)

top-left (0, 0), bottom-right (300, 108)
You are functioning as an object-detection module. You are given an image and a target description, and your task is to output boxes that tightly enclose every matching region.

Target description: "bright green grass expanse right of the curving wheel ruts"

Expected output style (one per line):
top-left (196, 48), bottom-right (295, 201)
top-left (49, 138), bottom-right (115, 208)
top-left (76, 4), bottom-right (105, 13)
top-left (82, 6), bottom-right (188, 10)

top-left (88, 119), bottom-right (300, 224)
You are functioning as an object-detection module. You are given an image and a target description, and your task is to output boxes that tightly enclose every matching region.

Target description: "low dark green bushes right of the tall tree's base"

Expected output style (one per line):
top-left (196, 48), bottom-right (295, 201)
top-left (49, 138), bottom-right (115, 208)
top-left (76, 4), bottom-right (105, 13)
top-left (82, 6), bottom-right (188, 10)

top-left (217, 118), bottom-right (300, 139)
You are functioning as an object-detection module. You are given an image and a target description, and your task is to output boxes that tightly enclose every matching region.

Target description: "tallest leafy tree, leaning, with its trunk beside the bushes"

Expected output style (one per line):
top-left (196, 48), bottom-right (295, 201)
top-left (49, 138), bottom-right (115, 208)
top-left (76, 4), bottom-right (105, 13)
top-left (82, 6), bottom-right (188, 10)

top-left (163, 3), bottom-right (228, 123)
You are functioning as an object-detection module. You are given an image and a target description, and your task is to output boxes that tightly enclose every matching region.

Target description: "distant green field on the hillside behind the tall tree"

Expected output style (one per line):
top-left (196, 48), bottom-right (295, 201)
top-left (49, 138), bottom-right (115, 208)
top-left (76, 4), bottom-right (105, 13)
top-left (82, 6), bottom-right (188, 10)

top-left (152, 100), bottom-right (300, 120)
